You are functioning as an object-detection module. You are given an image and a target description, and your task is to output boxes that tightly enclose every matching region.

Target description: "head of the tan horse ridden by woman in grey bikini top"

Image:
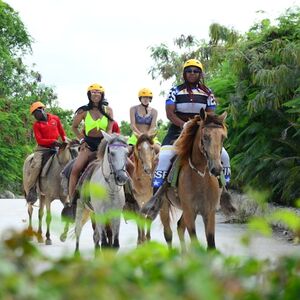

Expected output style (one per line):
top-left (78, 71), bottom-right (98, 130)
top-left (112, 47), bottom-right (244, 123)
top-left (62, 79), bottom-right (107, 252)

top-left (134, 134), bottom-right (155, 176)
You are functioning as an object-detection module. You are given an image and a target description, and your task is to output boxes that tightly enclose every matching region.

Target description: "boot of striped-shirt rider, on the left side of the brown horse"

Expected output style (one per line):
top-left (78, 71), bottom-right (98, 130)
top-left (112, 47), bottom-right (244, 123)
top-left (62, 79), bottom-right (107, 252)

top-left (141, 180), bottom-right (168, 220)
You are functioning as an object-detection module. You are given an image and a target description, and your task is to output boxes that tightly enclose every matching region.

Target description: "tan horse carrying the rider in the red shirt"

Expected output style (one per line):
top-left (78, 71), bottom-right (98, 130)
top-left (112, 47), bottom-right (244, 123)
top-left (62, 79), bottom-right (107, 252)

top-left (23, 141), bottom-right (79, 245)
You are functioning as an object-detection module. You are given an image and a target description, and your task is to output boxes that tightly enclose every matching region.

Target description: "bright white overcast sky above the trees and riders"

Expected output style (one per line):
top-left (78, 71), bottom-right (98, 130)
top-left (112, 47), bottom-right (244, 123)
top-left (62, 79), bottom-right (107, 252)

top-left (4, 0), bottom-right (300, 123)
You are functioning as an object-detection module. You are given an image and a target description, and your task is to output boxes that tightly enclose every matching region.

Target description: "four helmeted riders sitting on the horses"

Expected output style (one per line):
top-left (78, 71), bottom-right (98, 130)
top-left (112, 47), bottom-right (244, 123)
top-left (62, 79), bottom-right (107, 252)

top-left (26, 59), bottom-right (230, 218)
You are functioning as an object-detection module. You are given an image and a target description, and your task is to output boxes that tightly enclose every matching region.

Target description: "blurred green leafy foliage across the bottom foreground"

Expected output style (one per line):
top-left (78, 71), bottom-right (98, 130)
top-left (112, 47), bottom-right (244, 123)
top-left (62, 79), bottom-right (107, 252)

top-left (0, 226), bottom-right (300, 300)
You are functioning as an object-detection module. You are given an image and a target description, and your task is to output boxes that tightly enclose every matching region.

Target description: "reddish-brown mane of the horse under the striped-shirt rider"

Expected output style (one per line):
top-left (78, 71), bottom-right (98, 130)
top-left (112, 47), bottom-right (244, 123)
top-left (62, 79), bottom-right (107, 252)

top-left (174, 113), bottom-right (226, 164)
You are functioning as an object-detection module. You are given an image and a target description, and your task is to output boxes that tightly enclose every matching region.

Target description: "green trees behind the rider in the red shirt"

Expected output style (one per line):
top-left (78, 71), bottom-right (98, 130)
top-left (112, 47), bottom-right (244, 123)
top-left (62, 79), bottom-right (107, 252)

top-left (0, 0), bottom-right (71, 193)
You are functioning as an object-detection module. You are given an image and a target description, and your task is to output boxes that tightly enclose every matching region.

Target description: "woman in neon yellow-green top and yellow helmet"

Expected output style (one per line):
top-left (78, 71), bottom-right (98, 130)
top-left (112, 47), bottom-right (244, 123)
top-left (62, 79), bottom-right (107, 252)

top-left (69, 83), bottom-right (113, 204)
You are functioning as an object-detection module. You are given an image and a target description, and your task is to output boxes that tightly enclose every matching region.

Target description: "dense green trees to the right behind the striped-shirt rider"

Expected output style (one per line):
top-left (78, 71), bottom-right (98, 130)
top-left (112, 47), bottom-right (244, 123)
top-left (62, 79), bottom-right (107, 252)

top-left (150, 7), bottom-right (300, 205)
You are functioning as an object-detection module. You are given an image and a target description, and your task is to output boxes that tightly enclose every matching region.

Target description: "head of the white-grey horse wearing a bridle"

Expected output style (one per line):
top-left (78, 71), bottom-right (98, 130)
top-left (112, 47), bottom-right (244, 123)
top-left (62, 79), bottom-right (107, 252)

top-left (102, 131), bottom-right (129, 185)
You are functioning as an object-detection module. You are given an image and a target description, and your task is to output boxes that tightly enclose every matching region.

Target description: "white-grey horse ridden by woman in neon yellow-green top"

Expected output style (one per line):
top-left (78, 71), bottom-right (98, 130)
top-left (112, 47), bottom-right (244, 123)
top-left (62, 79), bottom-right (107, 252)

top-left (75, 131), bottom-right (129, 252)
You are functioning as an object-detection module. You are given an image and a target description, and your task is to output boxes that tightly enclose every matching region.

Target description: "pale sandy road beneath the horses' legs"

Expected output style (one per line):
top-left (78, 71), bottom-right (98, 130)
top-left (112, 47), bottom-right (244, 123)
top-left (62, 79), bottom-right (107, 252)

top-left (0, 199), bottom-right (300, 260)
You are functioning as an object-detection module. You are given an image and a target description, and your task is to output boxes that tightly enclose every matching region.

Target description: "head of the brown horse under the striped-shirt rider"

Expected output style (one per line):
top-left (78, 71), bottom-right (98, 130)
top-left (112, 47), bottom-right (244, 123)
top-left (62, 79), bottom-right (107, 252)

top-left (198, 109), bottom-right (227, 176)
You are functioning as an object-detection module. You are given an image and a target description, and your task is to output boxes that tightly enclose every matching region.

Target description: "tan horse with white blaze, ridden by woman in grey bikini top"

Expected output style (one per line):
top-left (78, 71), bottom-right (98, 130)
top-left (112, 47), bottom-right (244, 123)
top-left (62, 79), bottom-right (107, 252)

top-left (132, 134), bottom-right (156, 244)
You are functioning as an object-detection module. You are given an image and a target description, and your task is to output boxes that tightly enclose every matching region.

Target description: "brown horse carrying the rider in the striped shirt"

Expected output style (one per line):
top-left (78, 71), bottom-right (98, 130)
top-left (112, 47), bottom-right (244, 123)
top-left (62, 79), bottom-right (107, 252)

top-left (160, 109), bottom-right (227, 250)
